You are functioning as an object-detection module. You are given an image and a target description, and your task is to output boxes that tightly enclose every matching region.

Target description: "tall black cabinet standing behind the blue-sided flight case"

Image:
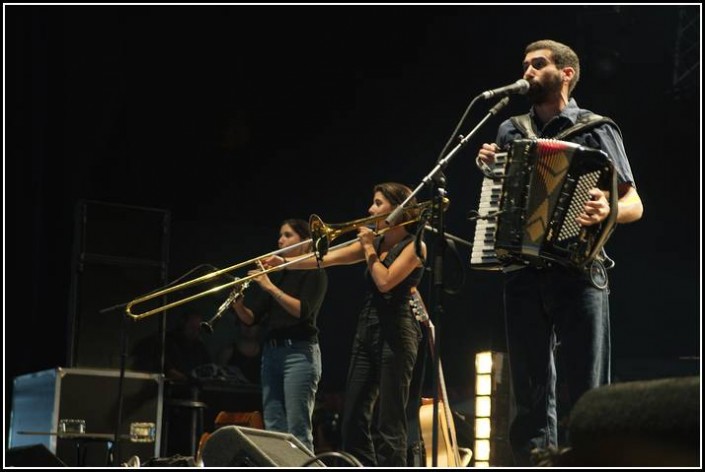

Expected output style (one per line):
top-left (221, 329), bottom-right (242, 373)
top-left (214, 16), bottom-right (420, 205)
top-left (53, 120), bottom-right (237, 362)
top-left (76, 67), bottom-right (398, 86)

top-left (67, 201), bottom-right (170, 372)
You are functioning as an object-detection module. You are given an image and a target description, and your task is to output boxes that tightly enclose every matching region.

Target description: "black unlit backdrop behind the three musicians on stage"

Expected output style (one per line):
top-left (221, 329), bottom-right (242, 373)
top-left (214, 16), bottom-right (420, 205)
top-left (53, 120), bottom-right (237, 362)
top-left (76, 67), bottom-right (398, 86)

top-left (4, 5), bottom-right (702, 446)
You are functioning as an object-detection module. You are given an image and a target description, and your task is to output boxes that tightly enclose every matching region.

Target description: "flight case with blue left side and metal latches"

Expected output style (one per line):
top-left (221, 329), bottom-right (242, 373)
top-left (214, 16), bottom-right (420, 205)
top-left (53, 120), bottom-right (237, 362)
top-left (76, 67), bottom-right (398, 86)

top-left (9, 368), bottom-right (163, 467)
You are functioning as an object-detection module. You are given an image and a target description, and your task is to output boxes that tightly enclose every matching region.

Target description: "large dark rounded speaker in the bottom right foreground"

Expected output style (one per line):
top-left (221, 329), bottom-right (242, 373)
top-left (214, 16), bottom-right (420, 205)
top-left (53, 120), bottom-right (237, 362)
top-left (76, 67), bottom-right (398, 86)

top-left (566, 376), bottom-right (700, 467)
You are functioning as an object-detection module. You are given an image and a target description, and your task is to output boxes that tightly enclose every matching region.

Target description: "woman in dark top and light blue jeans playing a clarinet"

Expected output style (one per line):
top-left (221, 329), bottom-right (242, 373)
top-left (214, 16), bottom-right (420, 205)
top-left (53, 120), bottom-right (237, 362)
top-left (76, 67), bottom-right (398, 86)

top-left (232, 219), bottom-right (328, 452)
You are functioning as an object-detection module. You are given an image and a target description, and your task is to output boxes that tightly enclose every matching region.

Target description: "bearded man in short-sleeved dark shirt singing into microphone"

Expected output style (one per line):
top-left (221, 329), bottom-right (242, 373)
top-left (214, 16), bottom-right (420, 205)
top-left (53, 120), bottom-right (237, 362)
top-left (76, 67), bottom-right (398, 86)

top-left (477, 40), bottom-right (643, 466)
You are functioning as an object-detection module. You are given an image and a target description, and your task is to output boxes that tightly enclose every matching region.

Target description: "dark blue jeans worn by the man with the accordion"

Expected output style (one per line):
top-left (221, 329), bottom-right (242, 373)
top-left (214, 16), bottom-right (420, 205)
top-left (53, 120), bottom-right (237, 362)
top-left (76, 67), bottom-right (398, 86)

top-left (504, 266), bottom-right (610, 466)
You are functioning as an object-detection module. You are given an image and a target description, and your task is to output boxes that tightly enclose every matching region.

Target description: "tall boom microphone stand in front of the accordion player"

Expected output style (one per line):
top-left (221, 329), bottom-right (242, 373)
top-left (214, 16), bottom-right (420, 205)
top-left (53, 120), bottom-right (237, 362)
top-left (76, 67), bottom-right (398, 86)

top-left (386, 95), bottom-right (509, 467)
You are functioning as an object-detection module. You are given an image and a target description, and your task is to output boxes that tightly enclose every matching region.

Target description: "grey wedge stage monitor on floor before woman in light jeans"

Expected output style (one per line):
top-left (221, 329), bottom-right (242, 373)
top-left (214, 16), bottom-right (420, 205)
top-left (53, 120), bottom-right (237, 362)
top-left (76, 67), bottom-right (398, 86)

top-left (201, 426), bottom-right (324, 467)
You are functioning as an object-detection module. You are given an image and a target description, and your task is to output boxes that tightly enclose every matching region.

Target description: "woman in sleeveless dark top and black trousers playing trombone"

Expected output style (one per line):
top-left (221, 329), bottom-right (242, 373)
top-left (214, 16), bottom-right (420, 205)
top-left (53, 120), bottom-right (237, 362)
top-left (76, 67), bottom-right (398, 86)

top-left (265, 182), bottom-right (426, 466)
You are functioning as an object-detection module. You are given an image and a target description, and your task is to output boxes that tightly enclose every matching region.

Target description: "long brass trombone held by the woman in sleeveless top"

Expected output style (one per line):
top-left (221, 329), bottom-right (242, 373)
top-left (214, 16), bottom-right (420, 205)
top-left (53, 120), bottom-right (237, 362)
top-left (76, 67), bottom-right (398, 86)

top-left (125, 197), bottom-right (449, 320)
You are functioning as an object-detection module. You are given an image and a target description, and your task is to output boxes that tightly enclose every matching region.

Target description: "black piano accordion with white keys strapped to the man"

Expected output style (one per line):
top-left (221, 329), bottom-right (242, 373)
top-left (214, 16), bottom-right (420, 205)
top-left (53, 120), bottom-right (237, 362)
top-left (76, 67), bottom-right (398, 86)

top-left (470, 139), bottom-right (617, 270)
